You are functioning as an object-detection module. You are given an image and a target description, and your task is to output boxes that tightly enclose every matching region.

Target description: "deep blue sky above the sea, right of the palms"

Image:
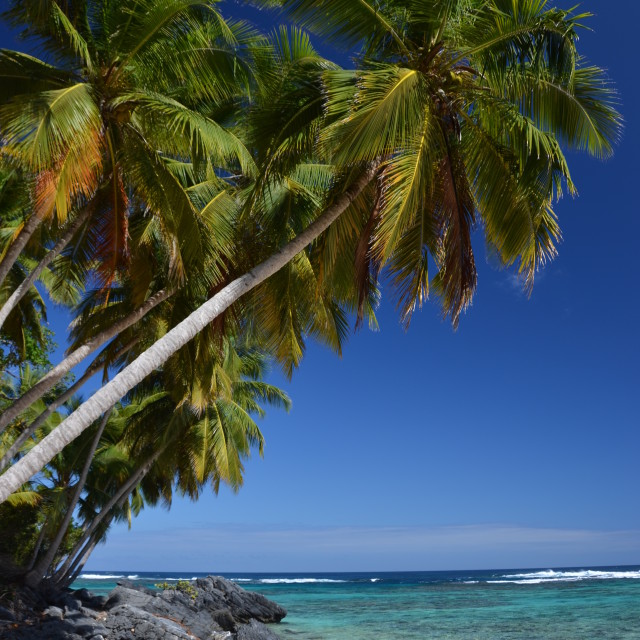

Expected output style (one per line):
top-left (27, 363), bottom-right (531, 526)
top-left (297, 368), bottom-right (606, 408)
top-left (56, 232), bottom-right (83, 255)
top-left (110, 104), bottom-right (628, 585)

top-left (2, 0), bottom-right (640, 572)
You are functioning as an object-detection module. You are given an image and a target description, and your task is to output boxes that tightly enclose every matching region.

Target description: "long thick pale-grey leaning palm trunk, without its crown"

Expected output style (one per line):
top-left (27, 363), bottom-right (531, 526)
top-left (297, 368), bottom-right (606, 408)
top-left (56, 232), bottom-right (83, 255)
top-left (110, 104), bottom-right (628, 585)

top-left (0, 166), bottom-right (378, 503)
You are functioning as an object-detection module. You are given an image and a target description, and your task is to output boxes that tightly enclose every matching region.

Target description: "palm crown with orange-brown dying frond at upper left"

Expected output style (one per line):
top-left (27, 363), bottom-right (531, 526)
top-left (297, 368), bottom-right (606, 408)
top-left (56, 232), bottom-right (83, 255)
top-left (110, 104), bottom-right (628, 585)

top-left (0, 0), bottom-right (252, 286)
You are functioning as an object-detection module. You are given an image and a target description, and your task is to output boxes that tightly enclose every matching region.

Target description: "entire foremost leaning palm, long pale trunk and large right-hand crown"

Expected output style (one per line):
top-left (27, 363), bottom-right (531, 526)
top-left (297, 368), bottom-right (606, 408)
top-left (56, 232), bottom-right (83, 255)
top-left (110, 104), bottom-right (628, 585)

top-left (0, 0), bottom-right (620, 499)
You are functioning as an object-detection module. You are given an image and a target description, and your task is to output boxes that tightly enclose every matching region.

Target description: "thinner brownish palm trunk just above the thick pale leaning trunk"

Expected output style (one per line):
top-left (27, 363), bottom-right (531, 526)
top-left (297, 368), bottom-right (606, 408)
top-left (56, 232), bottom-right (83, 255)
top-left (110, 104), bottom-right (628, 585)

top-left (0, 289), bottom-right (175, 433)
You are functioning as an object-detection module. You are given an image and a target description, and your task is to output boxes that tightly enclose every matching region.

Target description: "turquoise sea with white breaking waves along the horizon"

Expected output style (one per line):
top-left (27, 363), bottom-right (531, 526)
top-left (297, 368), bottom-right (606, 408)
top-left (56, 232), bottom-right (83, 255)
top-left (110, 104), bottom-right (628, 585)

top-left (73, 566), bottom-right (640, 640)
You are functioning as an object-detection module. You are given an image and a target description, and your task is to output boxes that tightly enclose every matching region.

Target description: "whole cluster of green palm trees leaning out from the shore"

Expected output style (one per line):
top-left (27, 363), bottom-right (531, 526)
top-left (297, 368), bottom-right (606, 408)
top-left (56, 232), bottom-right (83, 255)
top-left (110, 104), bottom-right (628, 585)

top-left (0, 0), bottom-right (620, 586)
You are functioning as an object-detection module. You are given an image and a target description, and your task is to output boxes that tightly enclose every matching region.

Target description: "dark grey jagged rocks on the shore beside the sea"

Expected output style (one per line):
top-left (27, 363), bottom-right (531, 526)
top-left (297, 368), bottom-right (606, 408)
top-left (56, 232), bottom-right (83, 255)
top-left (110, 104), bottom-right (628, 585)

top-left (0, 576), bottom-right (287, 640)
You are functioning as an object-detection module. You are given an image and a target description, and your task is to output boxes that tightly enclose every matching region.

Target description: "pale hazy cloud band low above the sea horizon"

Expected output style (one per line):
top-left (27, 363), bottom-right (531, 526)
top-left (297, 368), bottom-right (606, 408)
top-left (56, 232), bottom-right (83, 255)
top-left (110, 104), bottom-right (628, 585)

top-left (87, 524), bottom-right (640, 573)
